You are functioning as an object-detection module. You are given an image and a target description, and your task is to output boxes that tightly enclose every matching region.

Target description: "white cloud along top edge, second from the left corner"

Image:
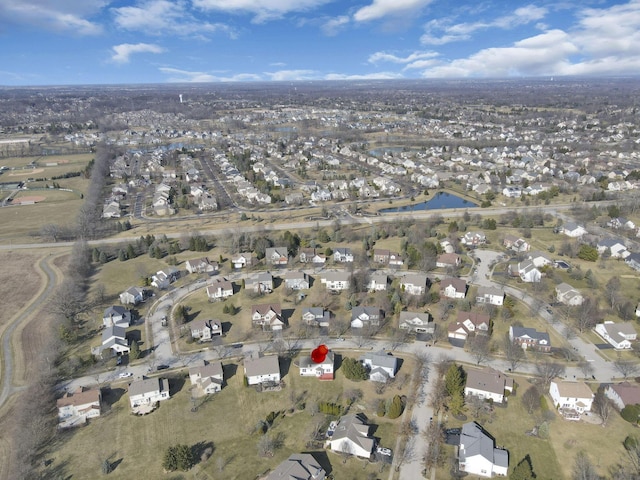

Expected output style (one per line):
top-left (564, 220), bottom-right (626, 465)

top-left (112, 0), bottom-right (235, 38)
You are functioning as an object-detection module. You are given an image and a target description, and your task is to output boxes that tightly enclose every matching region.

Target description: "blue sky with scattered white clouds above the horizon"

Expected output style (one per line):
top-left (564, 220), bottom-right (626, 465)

top-left (0, 0), bottom-right (640, 86)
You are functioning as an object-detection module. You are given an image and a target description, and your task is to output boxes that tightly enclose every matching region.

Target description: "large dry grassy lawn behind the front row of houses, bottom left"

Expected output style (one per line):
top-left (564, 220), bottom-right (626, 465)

top-left (43, 352), bottom-right (411, 480)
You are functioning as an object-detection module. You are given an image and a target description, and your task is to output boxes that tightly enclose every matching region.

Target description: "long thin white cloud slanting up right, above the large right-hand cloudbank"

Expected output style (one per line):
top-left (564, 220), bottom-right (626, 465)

top-left (420, 5), bottom-right (548, 45)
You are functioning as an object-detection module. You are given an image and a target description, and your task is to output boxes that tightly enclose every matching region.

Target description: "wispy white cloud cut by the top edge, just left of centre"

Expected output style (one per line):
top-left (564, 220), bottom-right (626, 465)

top-left (192, 0), bottom-right (332, 23)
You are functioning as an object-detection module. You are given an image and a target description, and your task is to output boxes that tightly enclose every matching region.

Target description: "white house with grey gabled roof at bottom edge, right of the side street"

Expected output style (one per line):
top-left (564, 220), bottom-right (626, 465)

top-left (458, 422), bottom-right (509, 478)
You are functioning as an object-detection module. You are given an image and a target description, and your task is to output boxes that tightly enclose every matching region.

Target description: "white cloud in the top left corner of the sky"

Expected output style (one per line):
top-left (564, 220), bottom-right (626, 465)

top-left (0, 0), bottom-right (108, 35)
